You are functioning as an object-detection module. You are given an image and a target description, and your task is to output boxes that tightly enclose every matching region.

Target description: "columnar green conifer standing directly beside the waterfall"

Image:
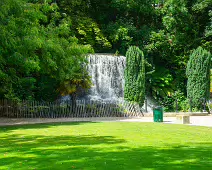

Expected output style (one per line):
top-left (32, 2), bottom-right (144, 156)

top-left (124, 46), bottom-right (145, 106)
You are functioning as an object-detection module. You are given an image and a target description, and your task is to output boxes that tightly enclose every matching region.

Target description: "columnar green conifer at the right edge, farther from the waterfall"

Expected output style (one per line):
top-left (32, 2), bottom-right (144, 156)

top-left (186, 47), bottom-right (211, 109)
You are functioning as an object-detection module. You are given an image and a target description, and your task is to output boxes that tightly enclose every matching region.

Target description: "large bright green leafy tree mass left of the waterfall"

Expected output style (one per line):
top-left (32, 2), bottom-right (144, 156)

top-left (0, 0), bottom-right (92, 100)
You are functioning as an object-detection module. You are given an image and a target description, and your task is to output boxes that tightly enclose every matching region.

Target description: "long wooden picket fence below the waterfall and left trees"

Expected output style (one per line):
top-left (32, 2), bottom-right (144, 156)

top-left (0, 100), bottom-right (143, 118)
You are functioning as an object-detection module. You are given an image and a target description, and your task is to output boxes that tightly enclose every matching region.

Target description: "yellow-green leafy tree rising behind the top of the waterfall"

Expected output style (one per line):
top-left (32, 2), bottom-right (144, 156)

top-left (57, 0), bottom-right (111, 52)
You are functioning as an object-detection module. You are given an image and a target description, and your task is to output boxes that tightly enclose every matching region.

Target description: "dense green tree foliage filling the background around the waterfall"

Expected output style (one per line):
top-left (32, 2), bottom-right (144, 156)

top-left (0, 0), bottom-right (212, 109)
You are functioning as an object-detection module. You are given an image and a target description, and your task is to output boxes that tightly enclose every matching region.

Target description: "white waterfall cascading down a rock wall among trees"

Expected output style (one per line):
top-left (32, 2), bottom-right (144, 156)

top-left (88, 54), bottom-right (126, 101)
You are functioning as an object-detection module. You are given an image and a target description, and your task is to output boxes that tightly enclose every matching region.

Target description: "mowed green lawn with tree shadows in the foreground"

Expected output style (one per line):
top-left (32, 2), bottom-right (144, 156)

top-left (0, 122), bottom-right (212, 170)
